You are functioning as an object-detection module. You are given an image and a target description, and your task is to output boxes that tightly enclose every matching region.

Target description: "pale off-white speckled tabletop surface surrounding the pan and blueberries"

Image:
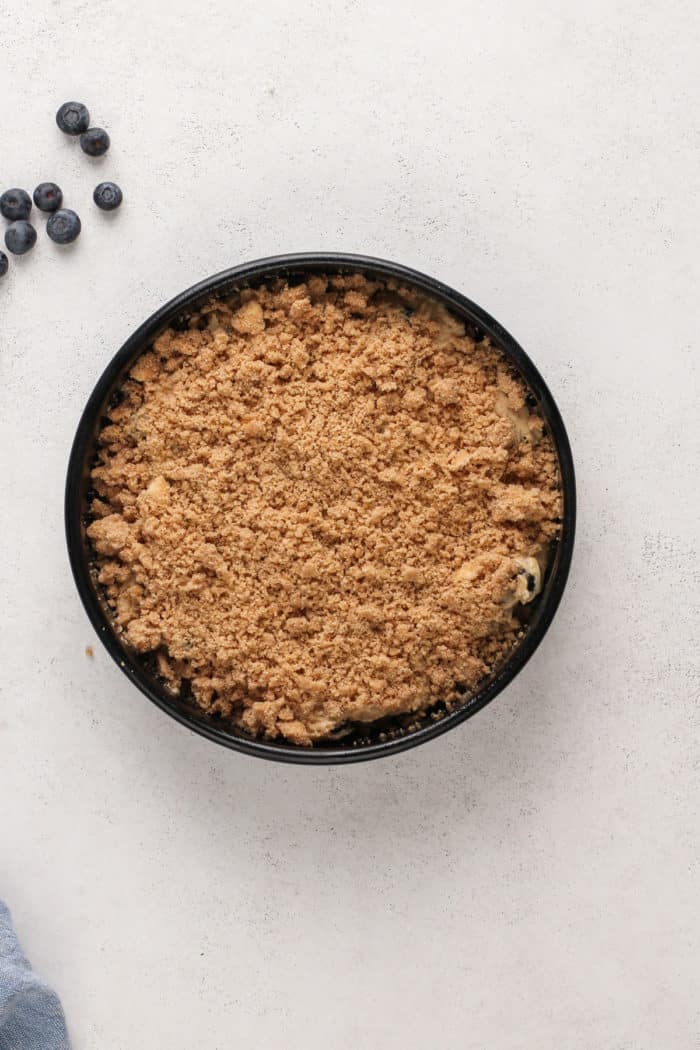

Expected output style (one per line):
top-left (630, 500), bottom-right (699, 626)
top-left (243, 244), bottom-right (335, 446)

top-left (0, 0), bottom-right (700, 1050)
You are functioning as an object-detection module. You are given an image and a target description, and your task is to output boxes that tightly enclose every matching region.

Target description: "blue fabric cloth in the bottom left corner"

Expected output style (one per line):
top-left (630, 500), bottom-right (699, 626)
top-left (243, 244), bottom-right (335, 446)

top-left (0, 901), bottom-right (70, 1050)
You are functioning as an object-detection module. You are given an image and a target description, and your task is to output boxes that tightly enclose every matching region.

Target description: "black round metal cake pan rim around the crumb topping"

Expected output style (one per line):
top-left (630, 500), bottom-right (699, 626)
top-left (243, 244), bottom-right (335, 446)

top-left (65, 252), bottom-right (576, 764)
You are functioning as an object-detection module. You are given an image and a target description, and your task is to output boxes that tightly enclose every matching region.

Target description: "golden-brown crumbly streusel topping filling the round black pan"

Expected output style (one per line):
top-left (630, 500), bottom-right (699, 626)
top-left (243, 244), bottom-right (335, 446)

top-left (88, 275), bottom-right (561, 744)
